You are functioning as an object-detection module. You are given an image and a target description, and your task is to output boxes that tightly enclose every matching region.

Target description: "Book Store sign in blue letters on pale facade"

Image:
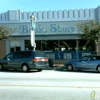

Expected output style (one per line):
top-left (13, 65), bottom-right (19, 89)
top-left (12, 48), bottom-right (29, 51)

top-left (20, 24), bottom-right (77, 34)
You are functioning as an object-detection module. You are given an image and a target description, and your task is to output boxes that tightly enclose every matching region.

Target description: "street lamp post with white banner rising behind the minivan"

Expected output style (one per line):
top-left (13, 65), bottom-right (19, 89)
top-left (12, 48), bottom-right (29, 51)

top-left (30, 15), bottom-right (36, 51)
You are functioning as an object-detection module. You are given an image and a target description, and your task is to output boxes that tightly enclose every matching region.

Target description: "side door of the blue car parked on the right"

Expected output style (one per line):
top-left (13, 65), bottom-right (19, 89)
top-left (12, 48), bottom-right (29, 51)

top-left (77, 56), bottom-right (91, 69)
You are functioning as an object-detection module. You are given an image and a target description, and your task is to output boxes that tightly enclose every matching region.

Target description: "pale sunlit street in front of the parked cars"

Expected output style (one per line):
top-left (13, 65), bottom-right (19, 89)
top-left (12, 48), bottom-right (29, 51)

top-left (0, 69), bottom-right (100, 100)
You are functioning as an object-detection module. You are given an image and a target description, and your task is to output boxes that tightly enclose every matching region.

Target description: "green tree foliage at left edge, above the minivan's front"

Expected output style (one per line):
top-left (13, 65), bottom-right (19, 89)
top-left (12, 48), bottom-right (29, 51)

top-left (0, 25), bottom-right (12, 41)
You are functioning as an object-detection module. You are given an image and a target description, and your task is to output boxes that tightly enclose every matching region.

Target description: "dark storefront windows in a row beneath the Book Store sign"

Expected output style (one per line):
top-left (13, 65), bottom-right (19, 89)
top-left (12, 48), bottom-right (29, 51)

top-left (25, 40), bottom-right (95, 51)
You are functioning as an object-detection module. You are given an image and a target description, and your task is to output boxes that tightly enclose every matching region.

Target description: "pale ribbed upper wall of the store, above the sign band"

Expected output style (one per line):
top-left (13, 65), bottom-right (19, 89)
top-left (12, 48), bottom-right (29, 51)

top-left (0, 7), bottom-right (100, 23)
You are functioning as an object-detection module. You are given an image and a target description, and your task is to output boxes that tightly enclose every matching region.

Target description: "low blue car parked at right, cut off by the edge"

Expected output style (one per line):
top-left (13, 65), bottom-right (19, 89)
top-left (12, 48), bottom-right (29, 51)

top-left (64, 55), bottom-right (100, 72)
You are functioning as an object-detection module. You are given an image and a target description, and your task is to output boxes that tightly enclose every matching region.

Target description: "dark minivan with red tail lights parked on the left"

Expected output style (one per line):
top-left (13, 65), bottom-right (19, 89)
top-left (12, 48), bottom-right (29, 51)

top-left (0, 51), bottom-right (49, 72)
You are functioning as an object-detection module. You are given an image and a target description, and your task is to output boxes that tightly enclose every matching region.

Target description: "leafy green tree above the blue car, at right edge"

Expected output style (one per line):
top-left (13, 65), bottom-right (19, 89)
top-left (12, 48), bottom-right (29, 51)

top-left (78, 21), bottom-right (100, 53)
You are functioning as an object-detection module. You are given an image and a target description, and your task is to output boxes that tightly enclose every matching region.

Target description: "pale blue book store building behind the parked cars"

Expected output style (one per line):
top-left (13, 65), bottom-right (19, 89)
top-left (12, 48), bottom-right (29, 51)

top-left (0, 6), bottom-right (100, 59)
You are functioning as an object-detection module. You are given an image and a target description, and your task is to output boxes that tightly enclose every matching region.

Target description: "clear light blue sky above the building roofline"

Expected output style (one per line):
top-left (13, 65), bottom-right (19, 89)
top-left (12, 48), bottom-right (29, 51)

top-left (0, 0), bottom-right (100, 13)
